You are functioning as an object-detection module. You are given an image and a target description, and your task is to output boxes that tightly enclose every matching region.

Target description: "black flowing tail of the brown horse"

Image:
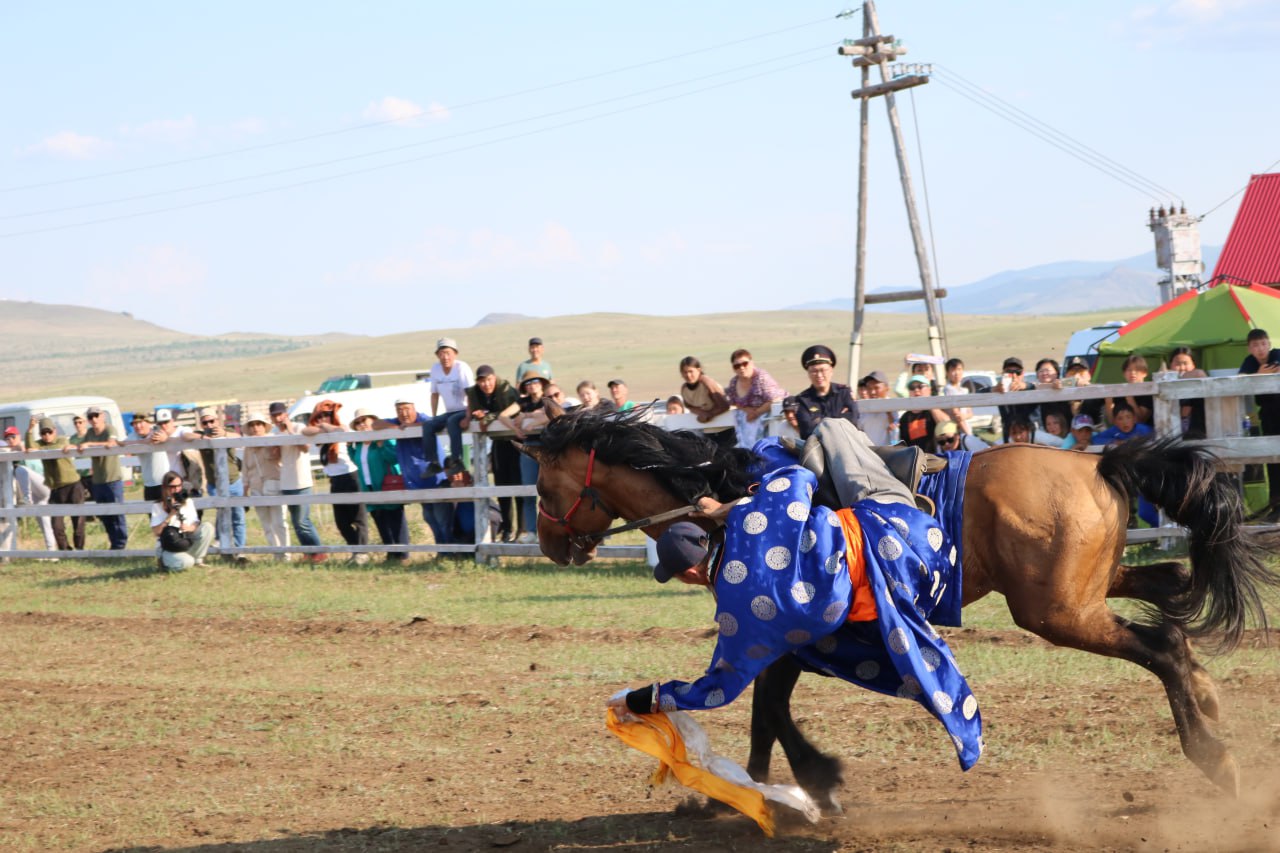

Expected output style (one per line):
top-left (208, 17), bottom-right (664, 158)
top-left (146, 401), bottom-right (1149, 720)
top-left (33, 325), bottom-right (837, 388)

top-left (1098, 438), bottom-right (1280, 652)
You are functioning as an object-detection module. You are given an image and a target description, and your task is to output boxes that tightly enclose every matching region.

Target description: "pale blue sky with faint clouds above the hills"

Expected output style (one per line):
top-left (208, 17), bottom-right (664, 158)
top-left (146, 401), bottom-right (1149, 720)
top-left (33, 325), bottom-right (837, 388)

top-left (0, 0), bottom-right (1280, 334)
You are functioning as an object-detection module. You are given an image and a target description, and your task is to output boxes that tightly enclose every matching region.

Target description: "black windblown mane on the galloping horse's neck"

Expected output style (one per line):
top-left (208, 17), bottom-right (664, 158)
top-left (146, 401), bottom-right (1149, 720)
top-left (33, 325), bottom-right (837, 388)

top-left (531, 409), bottom-right (758, 503)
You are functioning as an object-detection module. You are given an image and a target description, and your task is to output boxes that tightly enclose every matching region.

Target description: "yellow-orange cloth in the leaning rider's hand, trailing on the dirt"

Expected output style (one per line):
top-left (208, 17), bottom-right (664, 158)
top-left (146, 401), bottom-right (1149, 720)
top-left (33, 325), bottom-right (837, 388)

top-left (605, 708), bottom-right (773, 838)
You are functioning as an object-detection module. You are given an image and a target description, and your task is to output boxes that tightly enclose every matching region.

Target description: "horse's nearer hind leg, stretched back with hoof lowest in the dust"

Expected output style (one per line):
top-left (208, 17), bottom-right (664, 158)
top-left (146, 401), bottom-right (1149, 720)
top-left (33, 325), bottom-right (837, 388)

top-left (1010, 602), bottom-right (1240, 795)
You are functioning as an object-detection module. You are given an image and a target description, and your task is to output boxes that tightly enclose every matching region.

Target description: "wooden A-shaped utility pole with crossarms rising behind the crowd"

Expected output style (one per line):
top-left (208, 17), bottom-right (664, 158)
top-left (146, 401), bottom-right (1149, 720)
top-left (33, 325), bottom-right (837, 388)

top-left (838, 0), bottom-right (946, 386)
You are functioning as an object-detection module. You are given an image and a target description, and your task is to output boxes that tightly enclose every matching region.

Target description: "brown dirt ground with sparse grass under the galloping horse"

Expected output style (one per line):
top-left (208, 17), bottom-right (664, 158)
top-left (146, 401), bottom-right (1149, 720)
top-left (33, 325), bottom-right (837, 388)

top-left (0, 613), bottom-right (1280, 853)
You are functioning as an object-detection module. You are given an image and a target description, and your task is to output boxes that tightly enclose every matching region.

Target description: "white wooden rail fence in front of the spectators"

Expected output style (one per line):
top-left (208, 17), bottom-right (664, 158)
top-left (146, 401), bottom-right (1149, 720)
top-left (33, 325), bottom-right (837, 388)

top-left (0, 375), bottom-right (1280, 561)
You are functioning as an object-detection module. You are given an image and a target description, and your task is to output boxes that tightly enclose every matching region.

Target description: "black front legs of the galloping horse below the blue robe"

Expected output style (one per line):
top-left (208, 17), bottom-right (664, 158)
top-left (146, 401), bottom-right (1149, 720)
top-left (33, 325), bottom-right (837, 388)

top-left (746, 654), bottom-right (844, 813)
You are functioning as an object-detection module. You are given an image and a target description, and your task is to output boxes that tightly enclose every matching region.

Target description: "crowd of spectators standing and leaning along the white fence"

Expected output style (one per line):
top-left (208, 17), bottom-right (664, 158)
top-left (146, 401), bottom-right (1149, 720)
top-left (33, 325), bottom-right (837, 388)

top-left (0, 329), bottom-right (1280, 558)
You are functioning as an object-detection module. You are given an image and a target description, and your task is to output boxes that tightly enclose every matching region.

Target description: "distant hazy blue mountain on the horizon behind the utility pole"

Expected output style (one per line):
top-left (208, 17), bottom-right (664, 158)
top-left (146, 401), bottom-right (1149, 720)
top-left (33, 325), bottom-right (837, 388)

top-left (783, 246), bottom-right (1221, 314)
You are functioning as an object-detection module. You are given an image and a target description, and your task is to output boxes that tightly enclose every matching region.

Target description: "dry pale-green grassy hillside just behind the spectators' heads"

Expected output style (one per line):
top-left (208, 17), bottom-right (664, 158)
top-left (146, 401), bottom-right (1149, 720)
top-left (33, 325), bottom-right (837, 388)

top-left (0, 306), bottom-right (1137, 410)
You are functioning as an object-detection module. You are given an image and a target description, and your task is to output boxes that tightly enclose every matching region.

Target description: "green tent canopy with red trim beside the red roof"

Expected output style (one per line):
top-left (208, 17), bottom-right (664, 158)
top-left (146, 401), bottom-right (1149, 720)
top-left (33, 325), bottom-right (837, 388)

top-left (1093, 284), bottom-right (1280, 383)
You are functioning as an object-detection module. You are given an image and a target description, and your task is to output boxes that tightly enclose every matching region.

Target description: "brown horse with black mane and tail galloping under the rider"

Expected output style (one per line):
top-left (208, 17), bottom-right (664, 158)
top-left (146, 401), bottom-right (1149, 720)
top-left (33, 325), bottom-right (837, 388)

top-left (524, 412), bottom-right (1280, 808)
